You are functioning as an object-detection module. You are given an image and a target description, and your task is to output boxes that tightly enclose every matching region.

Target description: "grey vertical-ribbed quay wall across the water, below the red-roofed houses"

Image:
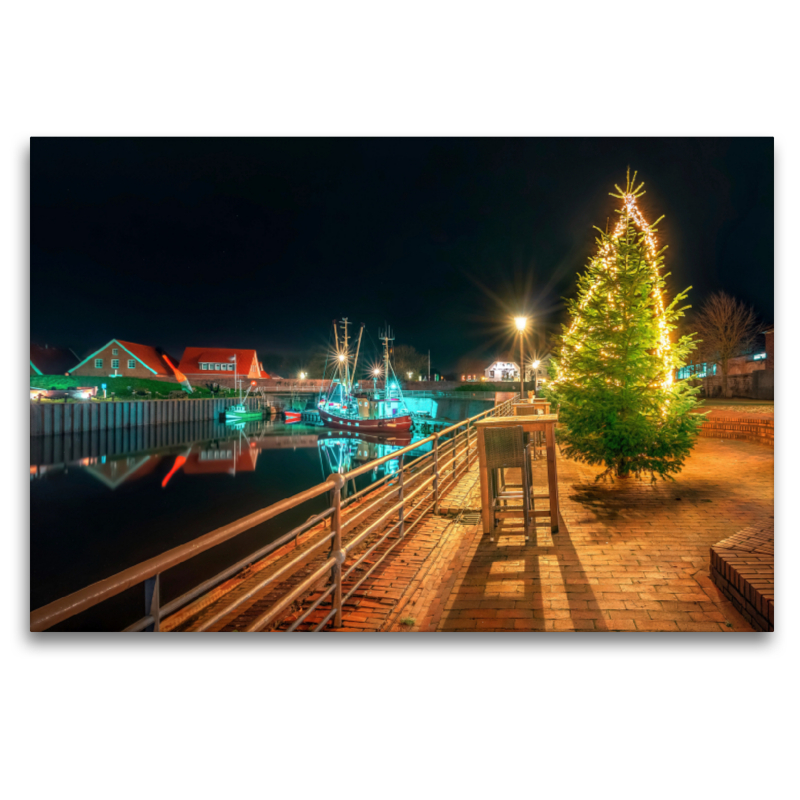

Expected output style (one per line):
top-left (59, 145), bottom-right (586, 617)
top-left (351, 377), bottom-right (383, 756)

top-left (30, 397), bottom-right (261, 436)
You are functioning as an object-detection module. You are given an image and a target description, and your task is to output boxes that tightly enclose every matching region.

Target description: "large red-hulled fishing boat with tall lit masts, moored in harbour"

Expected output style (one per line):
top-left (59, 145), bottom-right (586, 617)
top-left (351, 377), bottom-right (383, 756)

top-left (317, 318), bottom-right (413, 434)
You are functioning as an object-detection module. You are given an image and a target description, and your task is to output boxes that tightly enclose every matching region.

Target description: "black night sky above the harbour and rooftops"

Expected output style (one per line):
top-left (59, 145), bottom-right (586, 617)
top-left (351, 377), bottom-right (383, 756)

top-left (30, 138), bottom-right (774, 371)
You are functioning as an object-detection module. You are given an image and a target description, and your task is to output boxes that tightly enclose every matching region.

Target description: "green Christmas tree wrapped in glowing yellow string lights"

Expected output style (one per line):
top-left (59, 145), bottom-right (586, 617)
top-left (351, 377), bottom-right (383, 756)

top-left (546, 170), bottom-right (703, 480)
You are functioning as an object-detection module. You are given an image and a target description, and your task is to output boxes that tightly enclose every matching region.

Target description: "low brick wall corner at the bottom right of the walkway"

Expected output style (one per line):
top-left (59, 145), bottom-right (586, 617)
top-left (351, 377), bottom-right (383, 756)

top-left (711, 522), bottom-right (775, 631)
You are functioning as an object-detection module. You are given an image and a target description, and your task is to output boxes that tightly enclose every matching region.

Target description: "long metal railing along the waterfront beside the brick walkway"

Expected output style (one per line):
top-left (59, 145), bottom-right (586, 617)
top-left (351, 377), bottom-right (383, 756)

top-left (30, 395), bottom-right (517, 631)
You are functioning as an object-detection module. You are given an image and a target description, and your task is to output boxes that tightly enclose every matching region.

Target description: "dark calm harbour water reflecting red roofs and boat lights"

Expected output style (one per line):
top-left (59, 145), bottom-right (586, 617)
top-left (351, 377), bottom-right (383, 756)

top-left (30, 399), bottom-right (491, 631)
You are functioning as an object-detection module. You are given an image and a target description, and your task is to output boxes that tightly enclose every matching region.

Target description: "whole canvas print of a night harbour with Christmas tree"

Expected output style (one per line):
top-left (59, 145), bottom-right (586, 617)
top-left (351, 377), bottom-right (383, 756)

top-left (30, 137), bottom-right (775, 635)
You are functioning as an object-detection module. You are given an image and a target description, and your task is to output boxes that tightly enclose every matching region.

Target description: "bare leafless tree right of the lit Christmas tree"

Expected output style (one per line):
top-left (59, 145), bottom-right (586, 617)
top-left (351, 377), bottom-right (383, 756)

top-left (695, 292), bottom-right (757, 397)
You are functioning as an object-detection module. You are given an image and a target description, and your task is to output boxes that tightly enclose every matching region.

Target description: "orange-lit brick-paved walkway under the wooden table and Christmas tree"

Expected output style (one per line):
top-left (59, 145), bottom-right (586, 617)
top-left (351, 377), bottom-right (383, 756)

top-left (304, 439), bottom-right (773, 631)
